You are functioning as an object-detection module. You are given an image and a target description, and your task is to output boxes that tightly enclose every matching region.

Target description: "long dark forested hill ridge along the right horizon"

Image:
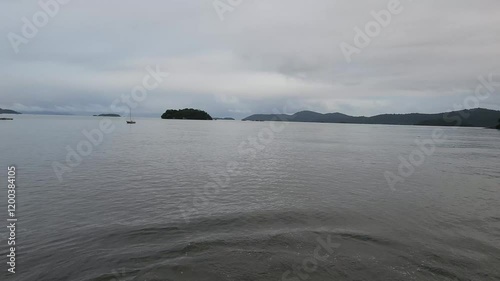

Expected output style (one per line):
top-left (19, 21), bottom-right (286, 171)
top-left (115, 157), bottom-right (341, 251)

top-left (243, 108), bottom-right (500, 127)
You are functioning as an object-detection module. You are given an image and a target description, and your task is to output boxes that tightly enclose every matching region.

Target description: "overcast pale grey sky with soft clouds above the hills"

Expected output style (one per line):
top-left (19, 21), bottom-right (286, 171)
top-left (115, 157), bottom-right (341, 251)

top-left (0, 0), bottom-right (500, 118)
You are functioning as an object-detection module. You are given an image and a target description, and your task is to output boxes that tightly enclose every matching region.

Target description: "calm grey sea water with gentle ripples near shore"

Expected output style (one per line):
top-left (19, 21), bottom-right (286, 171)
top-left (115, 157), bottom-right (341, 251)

top-left (0, 116), bottom-right (500, 281)
